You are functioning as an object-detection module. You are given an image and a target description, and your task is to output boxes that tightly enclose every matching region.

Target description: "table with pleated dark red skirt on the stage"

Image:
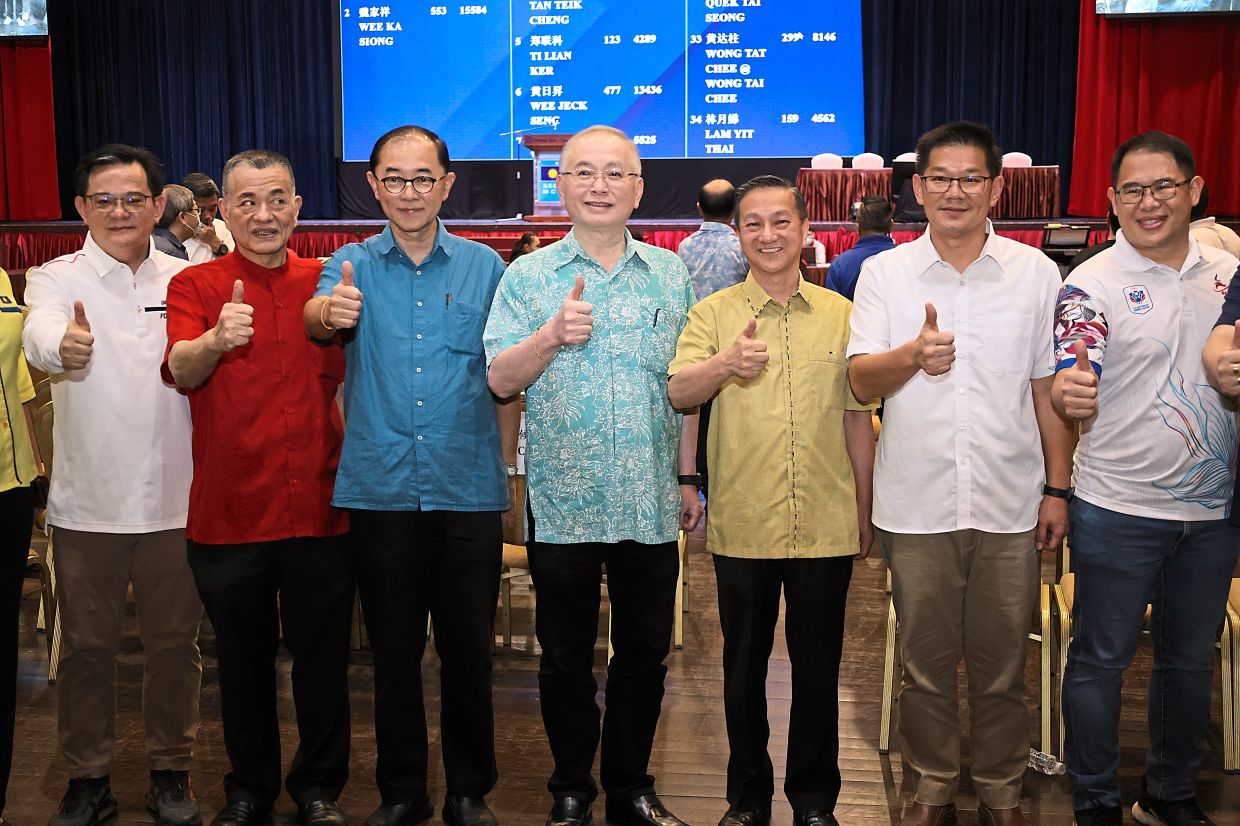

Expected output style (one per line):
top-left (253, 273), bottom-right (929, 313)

top-left (796, 166), bottom-right (1059, 221)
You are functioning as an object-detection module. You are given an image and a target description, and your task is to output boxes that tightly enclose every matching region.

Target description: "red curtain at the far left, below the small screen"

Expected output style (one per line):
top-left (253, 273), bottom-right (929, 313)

top-left (0, 42), bottom-right (61, 221)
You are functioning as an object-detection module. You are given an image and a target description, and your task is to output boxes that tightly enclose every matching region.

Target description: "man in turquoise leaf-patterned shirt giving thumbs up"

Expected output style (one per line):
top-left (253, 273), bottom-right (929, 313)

top-left (486, 127), bottom-right (702, 826)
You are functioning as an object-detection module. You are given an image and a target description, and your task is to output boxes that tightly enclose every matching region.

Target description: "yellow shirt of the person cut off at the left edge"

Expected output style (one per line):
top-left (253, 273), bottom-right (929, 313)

top-left (0, 269), bottom-right (37, 491)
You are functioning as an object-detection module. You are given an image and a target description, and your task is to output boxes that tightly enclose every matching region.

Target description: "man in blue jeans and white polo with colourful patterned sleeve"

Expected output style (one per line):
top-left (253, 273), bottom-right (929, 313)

top-left (1054, 131), bottom-right (1240, 826)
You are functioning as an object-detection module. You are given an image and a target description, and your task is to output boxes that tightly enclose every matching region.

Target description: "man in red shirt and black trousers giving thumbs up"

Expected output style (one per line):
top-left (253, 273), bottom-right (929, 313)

top-left (164, 150), bottom-right (353, 826)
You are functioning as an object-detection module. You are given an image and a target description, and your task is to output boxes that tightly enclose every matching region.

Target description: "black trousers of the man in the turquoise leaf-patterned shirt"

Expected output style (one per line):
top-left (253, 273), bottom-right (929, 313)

top-left (529, 506), bottom-right (680, 800)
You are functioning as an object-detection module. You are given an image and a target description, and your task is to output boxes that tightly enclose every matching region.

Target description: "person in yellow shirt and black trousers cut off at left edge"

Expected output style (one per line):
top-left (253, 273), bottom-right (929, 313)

top-left (0, 269), bottom-right (38, 824)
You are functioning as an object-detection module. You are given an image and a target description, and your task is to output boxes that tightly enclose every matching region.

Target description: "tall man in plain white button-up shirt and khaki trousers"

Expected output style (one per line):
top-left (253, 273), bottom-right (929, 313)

top-left (848, 122), bottom-right (1071, 826)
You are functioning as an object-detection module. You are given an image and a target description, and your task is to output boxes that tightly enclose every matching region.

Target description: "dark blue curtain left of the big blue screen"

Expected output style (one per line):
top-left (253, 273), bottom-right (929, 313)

top-left (47, 0), bottom-right (336, 218)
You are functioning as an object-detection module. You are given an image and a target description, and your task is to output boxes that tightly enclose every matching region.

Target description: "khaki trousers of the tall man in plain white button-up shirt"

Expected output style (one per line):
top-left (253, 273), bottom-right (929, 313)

top-left (877, 530), bottom-right (1038, 809)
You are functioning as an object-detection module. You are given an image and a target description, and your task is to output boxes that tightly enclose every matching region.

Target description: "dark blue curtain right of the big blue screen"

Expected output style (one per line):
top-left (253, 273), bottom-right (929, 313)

top-left (862, 0), bottom-right (1081, 203)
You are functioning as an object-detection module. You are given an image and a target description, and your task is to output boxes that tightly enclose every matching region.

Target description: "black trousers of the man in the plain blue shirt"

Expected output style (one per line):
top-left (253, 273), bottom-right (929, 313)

top-left (351, 511), bottom-right (503, 805)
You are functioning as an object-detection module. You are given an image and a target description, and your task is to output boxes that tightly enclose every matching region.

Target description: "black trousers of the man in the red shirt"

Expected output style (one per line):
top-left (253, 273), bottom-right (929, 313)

top-left (188, 537), bottom-right (356, 806)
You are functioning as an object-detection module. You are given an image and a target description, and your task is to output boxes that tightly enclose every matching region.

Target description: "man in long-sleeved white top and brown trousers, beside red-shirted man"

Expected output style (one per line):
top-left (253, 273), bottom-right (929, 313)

top-left (22, 144), bottom-right (202, 826)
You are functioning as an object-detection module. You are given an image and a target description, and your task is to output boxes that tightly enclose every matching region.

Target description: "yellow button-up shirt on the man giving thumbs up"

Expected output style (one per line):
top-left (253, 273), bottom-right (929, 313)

top-left (667, 273), bottom-right (872, 559)
